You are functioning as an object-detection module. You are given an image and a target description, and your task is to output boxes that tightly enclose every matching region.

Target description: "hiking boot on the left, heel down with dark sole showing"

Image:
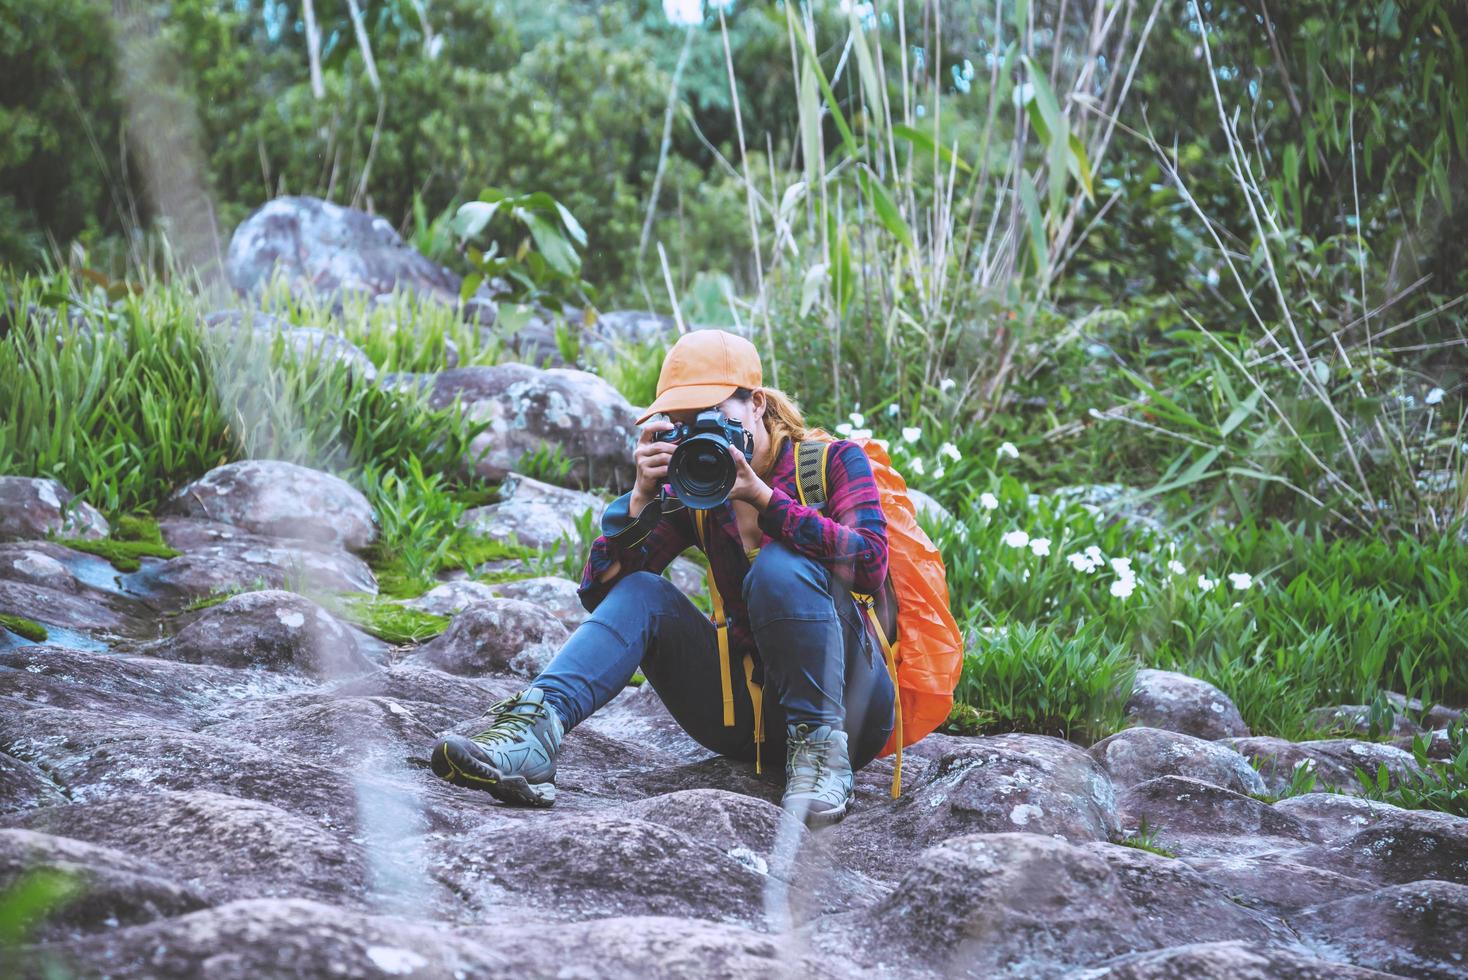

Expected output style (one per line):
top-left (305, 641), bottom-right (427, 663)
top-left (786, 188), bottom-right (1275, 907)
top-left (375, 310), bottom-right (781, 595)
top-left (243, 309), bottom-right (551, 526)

top-left (432, 687), bottom-right (565, 807)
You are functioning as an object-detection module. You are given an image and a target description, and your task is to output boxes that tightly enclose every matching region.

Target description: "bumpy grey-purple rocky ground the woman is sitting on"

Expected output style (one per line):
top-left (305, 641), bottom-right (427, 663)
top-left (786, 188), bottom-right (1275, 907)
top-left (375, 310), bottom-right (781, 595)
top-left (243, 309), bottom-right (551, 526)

top-left (0, 464), bottom-right (1468, 977)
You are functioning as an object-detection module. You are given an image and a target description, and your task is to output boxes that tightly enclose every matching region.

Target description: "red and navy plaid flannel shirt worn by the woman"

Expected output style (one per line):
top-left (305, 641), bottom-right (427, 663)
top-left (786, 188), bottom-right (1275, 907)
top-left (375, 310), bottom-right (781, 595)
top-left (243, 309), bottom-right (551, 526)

top-left (577, 439), bottom-right (887, 675)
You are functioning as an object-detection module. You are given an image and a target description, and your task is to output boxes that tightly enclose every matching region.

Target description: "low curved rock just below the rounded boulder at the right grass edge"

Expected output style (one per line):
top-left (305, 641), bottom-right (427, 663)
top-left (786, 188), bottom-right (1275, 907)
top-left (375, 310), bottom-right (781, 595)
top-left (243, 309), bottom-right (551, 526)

top-left (1089, 728), bottom-right (1264, 794)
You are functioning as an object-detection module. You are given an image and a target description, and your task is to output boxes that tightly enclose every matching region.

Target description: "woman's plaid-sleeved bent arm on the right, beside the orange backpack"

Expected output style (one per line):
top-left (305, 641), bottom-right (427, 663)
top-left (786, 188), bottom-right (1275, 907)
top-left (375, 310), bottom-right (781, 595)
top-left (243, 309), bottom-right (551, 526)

top-left (759, 439), bottom-right (887, 593)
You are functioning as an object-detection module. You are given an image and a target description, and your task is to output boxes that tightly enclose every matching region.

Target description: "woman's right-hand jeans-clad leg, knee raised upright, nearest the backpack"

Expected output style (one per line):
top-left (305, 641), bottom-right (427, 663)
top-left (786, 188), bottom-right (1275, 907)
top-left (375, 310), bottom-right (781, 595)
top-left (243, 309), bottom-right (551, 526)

top-left (744, 541), bottom-right (894, 770)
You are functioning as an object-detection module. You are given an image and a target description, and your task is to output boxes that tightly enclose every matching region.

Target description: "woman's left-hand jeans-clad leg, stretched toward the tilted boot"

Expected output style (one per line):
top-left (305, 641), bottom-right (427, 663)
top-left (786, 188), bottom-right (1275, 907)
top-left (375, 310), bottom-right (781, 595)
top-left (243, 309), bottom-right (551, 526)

top-left (531, 571), bottom-right (755, 758)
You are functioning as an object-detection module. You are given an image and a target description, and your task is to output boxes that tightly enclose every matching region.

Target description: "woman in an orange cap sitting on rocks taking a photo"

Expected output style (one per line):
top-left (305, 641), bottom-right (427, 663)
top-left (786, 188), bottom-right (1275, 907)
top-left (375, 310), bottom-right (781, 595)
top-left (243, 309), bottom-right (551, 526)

top-left (432, 330), bottom-right (894, 826)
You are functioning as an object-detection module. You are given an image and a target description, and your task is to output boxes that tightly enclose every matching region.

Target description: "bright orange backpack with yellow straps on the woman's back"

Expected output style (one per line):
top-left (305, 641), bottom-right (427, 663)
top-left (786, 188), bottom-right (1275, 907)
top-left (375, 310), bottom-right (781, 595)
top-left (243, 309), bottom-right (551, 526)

top-left (694, 430), bottom-right (963, 800)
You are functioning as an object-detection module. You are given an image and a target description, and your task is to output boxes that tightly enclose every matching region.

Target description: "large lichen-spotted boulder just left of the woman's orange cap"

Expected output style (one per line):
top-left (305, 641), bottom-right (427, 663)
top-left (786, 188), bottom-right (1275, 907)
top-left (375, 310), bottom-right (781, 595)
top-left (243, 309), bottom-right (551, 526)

top-left (430, 364), bottom-right (640, 493)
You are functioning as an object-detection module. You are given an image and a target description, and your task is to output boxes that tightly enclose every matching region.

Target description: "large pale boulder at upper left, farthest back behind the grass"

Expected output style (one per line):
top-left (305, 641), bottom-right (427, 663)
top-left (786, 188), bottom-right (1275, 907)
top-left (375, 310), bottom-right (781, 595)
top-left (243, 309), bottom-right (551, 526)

top-left (225, 197), bottom-right (472, 307)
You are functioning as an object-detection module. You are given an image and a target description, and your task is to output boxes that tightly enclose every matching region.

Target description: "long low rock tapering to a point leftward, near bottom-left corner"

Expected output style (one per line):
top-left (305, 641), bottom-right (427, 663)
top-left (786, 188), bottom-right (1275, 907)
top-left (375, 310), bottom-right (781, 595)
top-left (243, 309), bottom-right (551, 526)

top-left (10, 789), bottom-right (367, 904)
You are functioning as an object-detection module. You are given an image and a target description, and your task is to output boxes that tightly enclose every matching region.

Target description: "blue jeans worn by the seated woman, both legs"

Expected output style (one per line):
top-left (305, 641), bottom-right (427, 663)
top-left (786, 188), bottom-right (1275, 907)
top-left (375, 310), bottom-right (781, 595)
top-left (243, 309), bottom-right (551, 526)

top-left (533, 541), bottom-right (894, 770)
